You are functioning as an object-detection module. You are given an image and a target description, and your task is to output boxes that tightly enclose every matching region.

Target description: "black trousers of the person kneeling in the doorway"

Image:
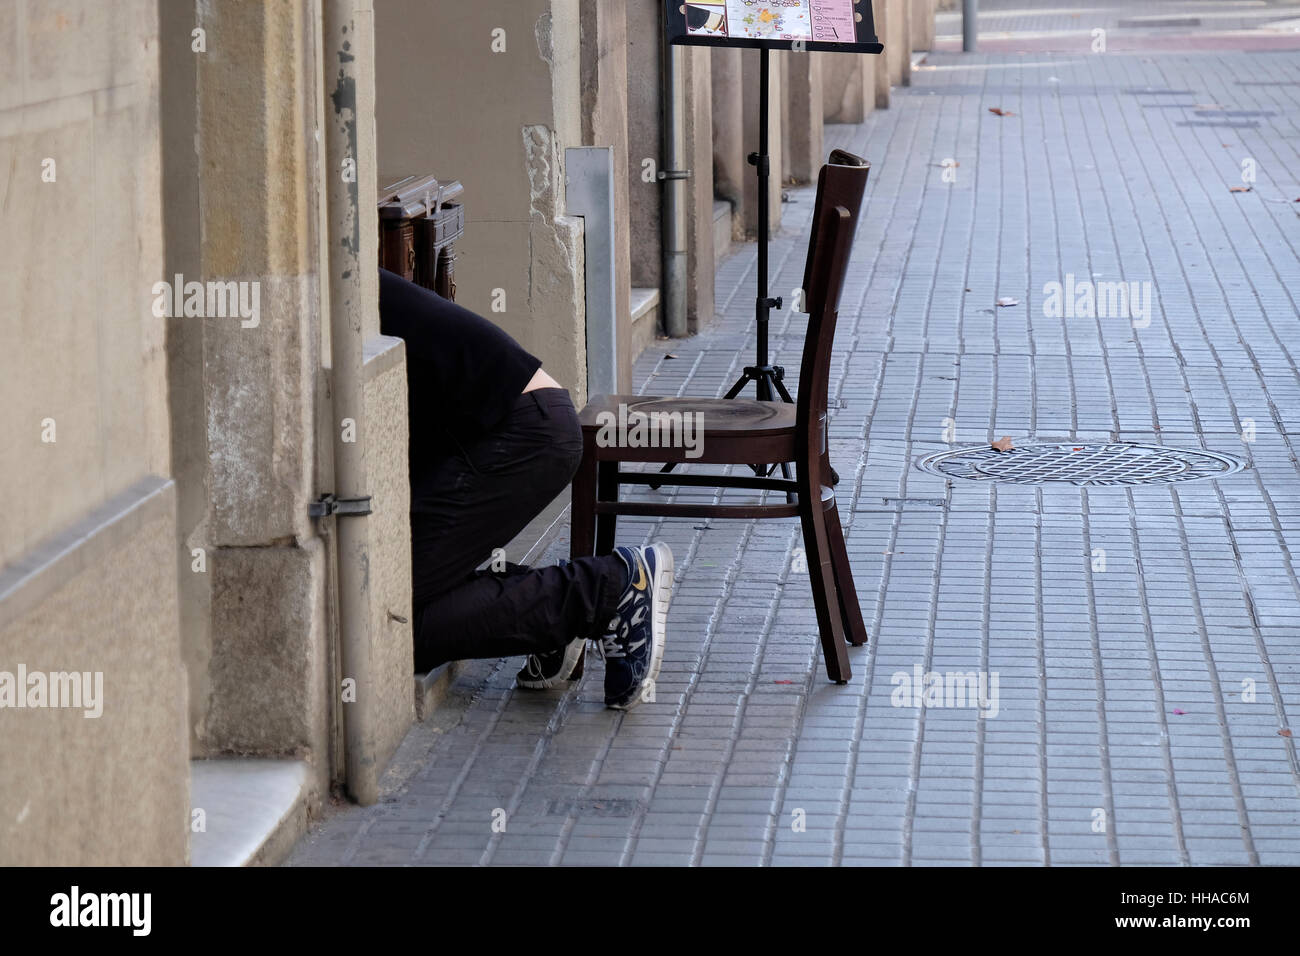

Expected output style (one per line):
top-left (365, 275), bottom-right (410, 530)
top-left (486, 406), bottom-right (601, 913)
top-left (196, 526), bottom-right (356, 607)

top-left (411, 388), bottom-right (627, 671)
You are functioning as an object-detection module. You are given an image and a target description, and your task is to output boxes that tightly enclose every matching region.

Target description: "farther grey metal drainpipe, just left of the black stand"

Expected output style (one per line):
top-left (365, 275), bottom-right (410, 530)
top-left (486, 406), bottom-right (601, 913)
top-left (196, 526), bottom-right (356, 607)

top-left (659, 38), bottom-right (689, 338)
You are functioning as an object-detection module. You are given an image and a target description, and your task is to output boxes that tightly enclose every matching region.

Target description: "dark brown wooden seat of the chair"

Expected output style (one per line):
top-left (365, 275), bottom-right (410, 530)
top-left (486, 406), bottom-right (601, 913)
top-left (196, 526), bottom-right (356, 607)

top-left (579, 395), bottom-right (796, 464)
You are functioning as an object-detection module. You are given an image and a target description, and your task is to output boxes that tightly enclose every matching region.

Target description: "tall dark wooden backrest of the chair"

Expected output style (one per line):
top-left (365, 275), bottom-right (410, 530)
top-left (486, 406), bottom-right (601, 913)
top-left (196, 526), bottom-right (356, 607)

top-left (797, 150), bottom-right (871, 454)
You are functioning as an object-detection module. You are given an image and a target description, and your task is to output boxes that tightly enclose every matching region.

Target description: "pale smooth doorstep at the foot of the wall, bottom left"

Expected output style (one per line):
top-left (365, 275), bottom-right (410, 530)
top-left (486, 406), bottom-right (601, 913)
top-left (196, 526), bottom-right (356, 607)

top-left (190, 757), bottom-right (311, 866)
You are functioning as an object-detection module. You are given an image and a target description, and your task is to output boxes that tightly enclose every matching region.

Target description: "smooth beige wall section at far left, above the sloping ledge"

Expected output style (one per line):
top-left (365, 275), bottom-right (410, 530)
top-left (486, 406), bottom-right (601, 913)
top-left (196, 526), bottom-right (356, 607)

top-left (0, 0), bottom-right (169, 567)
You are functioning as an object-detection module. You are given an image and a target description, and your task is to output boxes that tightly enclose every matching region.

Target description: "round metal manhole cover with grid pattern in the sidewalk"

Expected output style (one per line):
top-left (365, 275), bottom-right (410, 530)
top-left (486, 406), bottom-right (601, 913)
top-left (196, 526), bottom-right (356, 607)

top-left (917, 441), bottom-right (1245, 485)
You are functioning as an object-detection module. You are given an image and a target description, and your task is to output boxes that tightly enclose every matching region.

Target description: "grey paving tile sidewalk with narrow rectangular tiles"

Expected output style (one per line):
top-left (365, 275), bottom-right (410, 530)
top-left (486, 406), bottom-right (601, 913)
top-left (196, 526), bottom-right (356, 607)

top-left (290, 35), bottom-right (1300, 865)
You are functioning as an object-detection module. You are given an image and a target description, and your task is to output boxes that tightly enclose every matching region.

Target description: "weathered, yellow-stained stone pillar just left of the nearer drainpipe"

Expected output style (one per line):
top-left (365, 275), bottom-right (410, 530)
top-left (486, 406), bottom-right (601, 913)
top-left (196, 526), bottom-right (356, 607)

top-left (175, 3), bottom-right (329, 800)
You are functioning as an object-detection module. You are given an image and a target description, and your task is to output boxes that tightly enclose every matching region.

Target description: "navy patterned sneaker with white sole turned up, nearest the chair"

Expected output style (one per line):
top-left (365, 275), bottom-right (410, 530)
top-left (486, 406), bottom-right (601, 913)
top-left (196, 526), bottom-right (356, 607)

top-left (601, 541), bottom-right (672, 710)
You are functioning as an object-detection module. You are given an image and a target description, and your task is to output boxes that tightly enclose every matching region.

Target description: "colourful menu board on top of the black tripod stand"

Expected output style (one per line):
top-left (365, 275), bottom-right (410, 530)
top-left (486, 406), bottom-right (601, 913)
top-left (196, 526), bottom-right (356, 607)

top-left (666, 0), bottom-right (884, 53)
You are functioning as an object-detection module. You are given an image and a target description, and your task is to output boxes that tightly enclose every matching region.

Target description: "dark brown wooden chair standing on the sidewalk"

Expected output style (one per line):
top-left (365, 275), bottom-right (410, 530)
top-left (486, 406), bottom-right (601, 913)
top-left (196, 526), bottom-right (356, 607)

top-left (572, 150), bottom-right (870, 684)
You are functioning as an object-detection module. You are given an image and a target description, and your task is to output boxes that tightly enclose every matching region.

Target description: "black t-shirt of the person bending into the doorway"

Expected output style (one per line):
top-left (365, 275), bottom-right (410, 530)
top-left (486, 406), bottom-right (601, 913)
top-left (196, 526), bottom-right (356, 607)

top-left (380, 269), bottom-right (542, 505)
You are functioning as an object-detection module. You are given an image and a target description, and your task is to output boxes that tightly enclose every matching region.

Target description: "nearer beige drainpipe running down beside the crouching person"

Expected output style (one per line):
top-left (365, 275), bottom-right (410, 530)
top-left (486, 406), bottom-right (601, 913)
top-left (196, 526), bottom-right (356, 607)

top-left (321, 0), bottom-right (378, 805)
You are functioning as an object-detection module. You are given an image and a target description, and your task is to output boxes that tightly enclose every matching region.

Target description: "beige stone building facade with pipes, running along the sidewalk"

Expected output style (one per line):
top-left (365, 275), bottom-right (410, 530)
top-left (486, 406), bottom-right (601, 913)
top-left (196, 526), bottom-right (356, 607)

top-left (0, 0), bottom-right (935, 865)
